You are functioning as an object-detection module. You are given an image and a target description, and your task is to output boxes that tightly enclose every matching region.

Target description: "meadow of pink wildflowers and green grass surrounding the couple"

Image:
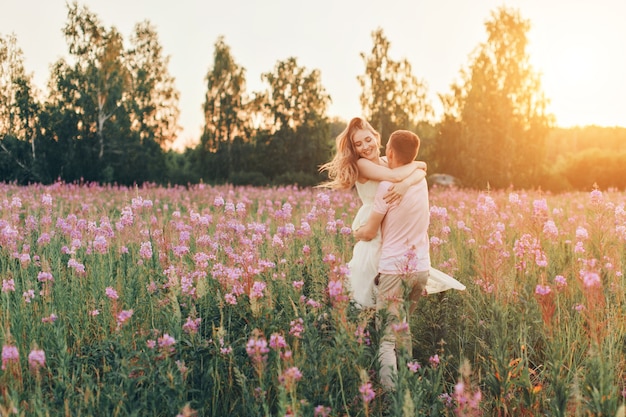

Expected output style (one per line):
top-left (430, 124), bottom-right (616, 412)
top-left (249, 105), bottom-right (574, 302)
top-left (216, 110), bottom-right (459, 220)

top-left (0, 183), bottom-right (626, 417)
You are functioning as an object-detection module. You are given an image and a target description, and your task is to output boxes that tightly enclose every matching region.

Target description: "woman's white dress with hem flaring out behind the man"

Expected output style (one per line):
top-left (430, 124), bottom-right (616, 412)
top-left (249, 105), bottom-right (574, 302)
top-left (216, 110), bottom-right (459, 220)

top-left (348, 180), bottom-right (465, 307)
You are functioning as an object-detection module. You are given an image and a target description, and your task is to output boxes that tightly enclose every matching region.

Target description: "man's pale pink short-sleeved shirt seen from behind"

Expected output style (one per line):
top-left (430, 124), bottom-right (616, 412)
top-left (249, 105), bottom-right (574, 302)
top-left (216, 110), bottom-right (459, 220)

top-left (374, 181), bottom-right (430, 274)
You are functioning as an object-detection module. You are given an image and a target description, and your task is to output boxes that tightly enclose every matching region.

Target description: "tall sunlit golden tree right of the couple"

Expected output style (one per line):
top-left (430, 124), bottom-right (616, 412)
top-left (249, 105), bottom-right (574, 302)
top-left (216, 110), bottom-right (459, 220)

top-left (437, 7), bottom-right (552, 189)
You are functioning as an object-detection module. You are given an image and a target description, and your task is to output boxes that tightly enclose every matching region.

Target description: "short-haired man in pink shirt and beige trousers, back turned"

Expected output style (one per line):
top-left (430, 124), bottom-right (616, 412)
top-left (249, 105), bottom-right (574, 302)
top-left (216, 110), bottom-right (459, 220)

top-left (354, 130), bottom-right (430, 390)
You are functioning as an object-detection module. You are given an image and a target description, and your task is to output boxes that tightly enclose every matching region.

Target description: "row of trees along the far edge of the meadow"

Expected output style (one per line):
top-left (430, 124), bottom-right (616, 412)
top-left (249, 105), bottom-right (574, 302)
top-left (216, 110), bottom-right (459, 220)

top-left (0, 2), bottom-right (623, 190)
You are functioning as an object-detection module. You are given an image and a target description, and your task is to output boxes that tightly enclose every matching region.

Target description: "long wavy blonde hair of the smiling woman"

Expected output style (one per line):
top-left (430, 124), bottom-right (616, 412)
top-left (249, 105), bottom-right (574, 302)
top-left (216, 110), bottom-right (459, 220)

top-left (319, 117), bottom-right (380, 189)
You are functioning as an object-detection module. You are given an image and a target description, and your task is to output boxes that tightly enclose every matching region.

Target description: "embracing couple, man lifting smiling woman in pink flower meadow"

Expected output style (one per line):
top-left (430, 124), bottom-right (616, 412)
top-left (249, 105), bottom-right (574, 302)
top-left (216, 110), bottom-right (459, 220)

top-left (321, 117), bottom-right (465, 389)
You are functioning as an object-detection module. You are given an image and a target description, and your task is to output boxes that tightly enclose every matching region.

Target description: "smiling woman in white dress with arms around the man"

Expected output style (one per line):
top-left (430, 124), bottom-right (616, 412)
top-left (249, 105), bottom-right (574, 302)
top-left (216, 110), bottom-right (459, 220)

top-left (320, 117), bottom-right (465, 307)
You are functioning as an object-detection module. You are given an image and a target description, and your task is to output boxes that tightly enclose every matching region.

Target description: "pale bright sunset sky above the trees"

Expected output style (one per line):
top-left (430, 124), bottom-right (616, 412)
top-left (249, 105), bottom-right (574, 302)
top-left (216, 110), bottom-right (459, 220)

top-left (0, 0), bottom-right (626, 149)
